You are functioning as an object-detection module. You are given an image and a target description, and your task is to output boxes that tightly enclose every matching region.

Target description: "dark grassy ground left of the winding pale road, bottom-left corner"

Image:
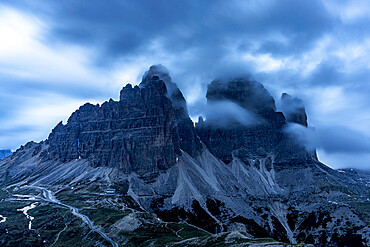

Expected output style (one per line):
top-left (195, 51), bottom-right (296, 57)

top-left (0, 188), bottom-right (110, 247)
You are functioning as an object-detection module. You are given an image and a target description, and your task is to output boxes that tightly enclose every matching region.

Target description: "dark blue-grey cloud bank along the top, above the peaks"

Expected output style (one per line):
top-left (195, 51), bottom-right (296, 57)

top-left (1, 0), bottom-right (335, 68)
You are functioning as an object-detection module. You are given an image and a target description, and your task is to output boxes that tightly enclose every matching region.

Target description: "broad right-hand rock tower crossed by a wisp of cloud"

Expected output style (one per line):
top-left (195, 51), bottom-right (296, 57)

top-left (196, 79), bottom-right (310, 167)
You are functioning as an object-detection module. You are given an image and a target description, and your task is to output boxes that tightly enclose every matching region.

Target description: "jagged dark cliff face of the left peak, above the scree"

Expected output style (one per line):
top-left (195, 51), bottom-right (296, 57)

top-left (46, 70), bottom-right (181, 178)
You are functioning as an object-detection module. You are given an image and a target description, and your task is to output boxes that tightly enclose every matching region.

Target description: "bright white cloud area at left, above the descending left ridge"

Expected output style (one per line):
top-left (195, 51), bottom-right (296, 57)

top-left (0, 7), bottom-right (135, 150)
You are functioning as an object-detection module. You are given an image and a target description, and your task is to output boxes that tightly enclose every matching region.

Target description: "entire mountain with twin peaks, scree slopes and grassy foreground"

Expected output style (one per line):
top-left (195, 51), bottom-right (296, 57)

top-left (0, 65), bottom-right (370, 246)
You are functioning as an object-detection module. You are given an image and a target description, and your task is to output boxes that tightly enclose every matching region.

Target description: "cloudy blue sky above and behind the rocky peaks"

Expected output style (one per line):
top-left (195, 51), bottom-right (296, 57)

top-left (0, 0), bottom-right (370, 169)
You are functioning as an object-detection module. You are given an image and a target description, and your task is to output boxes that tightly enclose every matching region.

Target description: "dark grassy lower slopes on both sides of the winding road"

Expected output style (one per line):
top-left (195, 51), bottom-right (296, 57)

top-left (0, 188), bottom-right (306, 247)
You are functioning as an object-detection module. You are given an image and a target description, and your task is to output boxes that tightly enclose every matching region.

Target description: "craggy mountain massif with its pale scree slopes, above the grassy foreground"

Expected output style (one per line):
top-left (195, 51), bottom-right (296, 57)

top-left (0, 66), bottom-right (370, 246)
